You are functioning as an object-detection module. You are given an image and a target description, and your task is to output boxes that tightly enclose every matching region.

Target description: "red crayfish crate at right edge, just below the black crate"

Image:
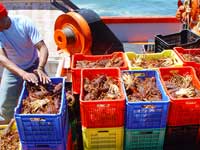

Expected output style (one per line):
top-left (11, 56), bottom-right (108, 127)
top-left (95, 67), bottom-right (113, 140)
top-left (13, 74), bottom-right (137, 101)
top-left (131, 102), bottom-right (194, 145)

top-left (174, 47), bottom-right (200, 79)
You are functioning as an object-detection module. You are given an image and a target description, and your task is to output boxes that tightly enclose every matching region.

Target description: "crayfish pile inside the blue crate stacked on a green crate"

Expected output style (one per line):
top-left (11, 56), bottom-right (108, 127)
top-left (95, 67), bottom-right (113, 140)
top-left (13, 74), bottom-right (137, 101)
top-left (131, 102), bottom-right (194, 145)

top-left (122, 73), bottom-right (162, 102)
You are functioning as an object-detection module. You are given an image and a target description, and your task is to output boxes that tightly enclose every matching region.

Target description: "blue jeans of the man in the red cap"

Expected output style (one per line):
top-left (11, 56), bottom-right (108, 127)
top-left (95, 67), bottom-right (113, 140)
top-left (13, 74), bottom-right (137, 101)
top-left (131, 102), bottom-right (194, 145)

top-left (0, 59), bottom-right (39, 121)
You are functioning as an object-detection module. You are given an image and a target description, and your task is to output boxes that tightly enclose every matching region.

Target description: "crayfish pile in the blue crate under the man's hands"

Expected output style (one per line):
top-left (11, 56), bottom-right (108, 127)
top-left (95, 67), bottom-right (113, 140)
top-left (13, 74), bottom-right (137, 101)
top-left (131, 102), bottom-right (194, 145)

top-left (21, 83), bottom-right (62, 114)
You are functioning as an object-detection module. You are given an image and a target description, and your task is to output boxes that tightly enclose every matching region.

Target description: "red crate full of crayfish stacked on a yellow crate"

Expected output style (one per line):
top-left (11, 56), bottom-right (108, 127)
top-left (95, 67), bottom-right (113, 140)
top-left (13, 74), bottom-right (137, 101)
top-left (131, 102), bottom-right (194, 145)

top-left (80, 68), bottom-right (125, 128)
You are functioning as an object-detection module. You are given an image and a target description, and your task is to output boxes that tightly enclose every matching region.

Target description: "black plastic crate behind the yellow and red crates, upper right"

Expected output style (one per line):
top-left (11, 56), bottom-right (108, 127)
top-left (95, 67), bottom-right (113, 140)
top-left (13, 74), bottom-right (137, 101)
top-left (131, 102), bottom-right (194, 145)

top-left (155, 30), bottom-right (200, 52)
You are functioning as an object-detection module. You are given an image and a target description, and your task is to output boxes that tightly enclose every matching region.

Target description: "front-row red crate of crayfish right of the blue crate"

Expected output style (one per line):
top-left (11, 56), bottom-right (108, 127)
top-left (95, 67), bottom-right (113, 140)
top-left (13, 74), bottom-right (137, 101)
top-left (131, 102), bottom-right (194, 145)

top-left (159, 66), bottom-right (200, 126)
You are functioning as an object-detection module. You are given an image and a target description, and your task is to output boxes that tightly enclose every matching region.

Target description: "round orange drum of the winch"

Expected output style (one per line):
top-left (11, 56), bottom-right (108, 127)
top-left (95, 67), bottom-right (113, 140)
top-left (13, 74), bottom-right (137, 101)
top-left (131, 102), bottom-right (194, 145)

top-left (54, 12), bottom-right (92, 55)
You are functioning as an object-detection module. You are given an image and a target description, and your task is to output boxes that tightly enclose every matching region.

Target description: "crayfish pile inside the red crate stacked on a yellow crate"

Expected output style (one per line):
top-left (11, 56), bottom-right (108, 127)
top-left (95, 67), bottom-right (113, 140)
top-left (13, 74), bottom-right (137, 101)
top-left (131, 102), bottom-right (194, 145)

top-left (84, 75), bottom-right (121, 101)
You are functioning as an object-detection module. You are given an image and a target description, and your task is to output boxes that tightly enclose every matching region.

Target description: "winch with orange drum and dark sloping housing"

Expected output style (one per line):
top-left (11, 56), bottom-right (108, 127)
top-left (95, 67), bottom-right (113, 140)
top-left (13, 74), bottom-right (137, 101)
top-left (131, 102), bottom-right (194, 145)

top-left (51, 0), bottom-right (124, 55)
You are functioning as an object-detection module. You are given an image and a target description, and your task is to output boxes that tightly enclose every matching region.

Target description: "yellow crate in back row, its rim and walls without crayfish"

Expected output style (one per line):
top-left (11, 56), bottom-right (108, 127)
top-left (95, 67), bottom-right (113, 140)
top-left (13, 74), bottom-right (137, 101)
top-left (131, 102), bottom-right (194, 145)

top-left (125, 50), bottom-right (183, 70)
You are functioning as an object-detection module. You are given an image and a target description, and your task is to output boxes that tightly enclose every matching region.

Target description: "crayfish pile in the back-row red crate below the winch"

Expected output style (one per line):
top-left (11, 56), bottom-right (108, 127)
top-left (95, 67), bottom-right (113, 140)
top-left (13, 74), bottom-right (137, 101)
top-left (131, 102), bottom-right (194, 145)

top-left (76, 55), bottom-right (124, 68)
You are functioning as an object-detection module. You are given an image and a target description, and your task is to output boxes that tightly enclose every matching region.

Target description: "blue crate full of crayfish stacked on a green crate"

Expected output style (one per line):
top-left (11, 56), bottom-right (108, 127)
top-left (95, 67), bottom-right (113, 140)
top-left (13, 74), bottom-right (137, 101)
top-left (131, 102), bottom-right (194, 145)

top-left (122, 70), bottom-right (169, 129)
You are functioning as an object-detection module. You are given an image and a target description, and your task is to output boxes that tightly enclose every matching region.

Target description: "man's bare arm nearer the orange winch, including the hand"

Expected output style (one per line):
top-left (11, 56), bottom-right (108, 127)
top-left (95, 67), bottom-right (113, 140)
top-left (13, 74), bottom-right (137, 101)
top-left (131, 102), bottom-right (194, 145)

top-left (35, 40), bottom-right (50, 84)
